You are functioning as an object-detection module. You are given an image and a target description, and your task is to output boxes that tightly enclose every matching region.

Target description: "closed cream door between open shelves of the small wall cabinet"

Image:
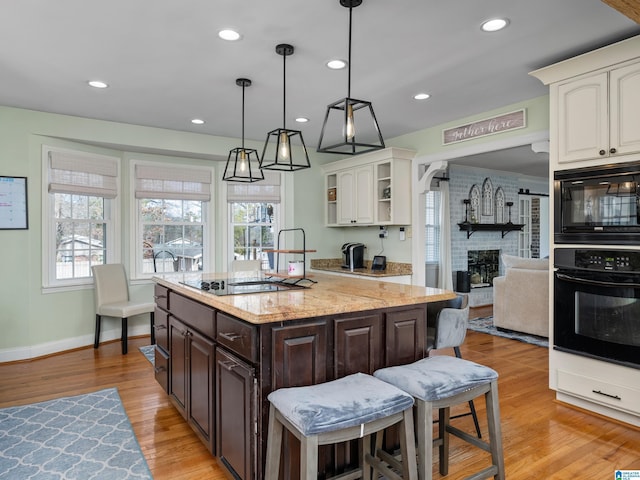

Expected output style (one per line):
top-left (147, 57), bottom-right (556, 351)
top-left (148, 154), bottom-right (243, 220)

top-left (337, 165), bottom-right (373, 225)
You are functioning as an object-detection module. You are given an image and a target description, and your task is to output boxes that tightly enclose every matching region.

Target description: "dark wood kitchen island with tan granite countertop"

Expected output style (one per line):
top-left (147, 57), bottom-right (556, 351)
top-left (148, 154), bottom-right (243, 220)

top-left (154, 273), bottom-right (455, 480)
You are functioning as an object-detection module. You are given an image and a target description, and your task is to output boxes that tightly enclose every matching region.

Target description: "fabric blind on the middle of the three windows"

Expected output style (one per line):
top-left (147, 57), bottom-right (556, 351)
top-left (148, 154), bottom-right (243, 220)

top-left (135, 165), bottom-right (211, 202)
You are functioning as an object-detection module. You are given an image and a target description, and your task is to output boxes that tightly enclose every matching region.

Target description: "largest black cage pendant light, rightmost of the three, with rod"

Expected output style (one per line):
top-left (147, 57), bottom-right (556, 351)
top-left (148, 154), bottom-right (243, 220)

top-left (318, 0), bottom-right (384, 155)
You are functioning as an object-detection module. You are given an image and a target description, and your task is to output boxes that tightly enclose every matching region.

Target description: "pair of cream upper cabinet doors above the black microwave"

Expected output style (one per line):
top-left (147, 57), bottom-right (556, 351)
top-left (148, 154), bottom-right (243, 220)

top-left (558, 63), bottom-right (640, 163)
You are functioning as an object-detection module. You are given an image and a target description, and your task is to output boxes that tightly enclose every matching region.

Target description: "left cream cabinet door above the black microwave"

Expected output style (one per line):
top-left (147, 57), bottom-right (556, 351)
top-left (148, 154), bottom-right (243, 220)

top-left (558, 72), bottom-right (609, 163)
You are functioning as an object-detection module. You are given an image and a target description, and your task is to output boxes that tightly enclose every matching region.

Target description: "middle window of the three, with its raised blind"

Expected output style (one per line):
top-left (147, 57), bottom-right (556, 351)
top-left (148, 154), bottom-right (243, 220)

top-left (134, 163), bottom-right (212, 278)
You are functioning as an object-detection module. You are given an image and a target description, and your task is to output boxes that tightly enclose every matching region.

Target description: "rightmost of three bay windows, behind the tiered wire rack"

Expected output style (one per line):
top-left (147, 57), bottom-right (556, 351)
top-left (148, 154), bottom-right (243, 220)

top-left (227, 171), bottom-right (280, 270)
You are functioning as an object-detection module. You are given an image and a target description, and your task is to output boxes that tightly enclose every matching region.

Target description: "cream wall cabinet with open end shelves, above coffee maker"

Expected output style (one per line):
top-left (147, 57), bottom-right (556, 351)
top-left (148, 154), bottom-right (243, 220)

top-left (323, 148), bottom-right (415, 227)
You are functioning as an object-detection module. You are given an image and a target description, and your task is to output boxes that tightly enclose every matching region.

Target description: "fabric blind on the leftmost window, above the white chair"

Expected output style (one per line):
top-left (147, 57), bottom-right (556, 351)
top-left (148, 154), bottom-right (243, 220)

top-left (49, 150), bottom-right (118, 198)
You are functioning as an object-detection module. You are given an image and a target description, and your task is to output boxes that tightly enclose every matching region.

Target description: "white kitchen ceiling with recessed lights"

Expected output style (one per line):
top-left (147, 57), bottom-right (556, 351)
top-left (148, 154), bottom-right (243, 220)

top-left (0, 0), bottom-right (640, 176)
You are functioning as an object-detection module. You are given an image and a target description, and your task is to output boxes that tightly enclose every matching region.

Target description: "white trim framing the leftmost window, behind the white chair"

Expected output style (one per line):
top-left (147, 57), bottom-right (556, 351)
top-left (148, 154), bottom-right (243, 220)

top-left (42, 145), bottom-right (122, 293)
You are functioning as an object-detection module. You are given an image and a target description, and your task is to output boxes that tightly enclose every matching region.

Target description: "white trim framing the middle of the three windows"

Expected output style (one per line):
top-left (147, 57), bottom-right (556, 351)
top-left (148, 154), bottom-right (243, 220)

top-left (129, 159), bottom-right (216, 284)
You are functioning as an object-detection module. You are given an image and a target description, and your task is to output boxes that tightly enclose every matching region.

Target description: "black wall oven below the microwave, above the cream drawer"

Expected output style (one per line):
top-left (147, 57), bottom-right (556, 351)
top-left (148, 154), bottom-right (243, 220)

top-left (553, 248), bottom-right (640, 368)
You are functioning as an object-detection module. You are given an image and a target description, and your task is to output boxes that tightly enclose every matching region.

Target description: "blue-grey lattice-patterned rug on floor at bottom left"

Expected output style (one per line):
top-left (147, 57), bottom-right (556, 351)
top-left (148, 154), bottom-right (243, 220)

top-left (0, 388), bottom-right (153, 480)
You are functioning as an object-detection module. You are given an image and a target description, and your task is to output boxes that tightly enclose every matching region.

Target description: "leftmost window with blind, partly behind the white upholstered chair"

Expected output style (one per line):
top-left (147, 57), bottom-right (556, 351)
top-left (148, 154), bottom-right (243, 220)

top-left (43, 147), bottom-right (119, 287)
